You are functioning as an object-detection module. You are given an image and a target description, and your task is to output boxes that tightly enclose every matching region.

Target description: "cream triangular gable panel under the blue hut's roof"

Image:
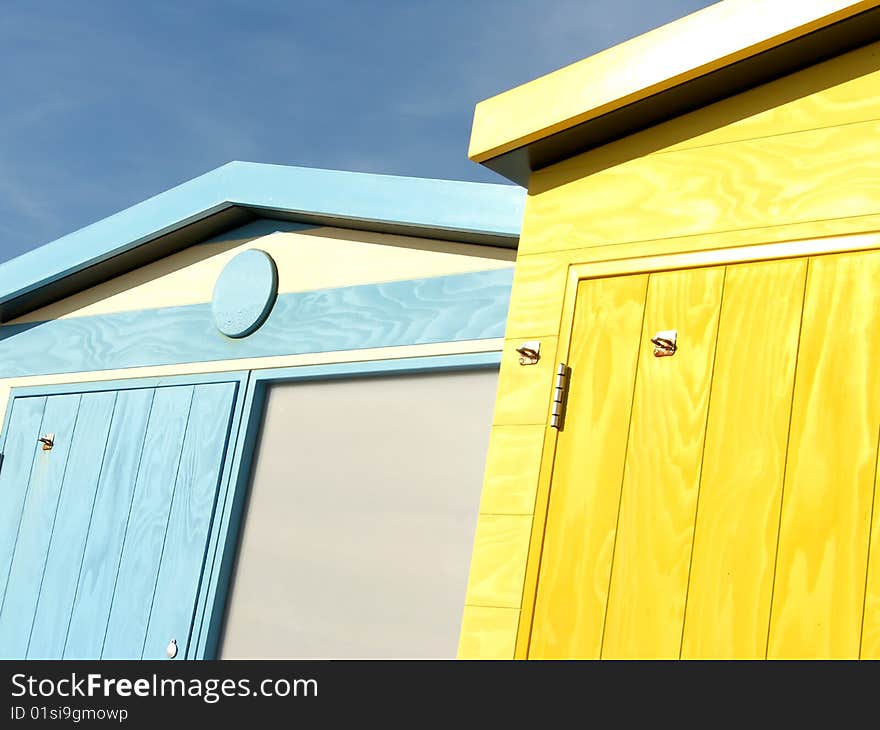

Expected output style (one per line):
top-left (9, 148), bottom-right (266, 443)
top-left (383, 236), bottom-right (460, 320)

top-left (12, 228), bottom-right (516, 322)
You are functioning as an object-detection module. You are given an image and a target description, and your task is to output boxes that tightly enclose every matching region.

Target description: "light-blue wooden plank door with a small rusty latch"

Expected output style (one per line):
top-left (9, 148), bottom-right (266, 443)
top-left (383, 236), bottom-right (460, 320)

top-left (0, 382), bottom-right (238, 659)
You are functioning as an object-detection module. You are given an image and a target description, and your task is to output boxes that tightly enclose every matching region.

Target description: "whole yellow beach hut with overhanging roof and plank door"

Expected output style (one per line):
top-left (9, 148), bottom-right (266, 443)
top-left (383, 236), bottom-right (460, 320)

top-left (459, 0), bottom-right (880, 658)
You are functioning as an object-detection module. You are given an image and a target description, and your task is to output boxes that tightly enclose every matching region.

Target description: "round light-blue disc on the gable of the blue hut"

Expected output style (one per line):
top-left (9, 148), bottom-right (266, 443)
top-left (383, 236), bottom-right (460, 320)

top-left (211, 248), bottom-right (278, 337)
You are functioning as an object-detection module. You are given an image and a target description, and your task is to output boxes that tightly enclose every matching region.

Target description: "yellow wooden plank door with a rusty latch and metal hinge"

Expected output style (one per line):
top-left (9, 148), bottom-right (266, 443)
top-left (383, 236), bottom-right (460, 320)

top-left (529, 247), bottom-right (880, 658)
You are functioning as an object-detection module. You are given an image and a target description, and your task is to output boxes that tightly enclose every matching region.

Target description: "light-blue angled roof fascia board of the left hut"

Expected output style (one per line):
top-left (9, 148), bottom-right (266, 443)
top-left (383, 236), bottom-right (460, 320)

top-left (0, 162), bottom-right (526, 308)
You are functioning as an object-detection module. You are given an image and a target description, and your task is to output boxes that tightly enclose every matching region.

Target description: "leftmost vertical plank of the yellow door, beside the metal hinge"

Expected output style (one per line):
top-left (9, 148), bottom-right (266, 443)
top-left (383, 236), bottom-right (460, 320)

top-left (529, 276), bottom-right (648, 658)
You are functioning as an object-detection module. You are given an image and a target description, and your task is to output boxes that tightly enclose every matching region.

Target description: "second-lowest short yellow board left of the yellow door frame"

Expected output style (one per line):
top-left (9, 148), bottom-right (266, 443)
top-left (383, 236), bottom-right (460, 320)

top-left (465, 515), bottom-right (532, 608)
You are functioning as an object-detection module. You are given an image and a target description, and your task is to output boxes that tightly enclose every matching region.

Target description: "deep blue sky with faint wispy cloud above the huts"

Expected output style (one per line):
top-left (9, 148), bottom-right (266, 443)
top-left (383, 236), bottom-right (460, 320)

top-left (0, 0), bottom-right (711, 261)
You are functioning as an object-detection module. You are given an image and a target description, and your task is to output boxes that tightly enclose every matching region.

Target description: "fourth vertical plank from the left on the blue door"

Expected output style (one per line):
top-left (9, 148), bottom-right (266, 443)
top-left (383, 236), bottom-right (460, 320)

top-left (64, 389), bottom-right (155, 659)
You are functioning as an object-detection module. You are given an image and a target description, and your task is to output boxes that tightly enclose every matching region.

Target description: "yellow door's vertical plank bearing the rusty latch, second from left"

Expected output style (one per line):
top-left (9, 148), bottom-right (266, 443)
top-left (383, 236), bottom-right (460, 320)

top-left (602, 268), bottom-right (724, 658)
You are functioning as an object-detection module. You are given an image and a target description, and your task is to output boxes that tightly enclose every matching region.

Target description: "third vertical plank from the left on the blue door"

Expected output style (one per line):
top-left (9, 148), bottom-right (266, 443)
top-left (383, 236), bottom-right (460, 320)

top-left (27, 392), bottom-right (119, 659)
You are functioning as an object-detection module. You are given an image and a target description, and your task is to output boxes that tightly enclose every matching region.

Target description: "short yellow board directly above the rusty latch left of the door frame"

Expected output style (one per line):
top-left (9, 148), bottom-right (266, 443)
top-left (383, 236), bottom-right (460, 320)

top-left (505, 247), bottom-right (570, 339)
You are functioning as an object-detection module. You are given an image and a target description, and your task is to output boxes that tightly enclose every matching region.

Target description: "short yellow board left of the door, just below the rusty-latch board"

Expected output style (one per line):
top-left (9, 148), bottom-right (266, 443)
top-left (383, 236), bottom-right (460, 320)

top-left (480, 426), bottom-right (544, 515)
